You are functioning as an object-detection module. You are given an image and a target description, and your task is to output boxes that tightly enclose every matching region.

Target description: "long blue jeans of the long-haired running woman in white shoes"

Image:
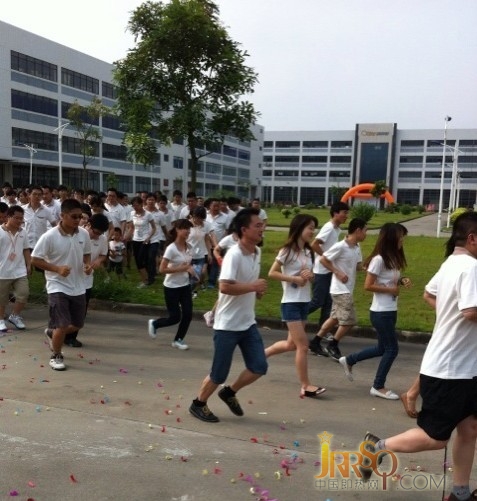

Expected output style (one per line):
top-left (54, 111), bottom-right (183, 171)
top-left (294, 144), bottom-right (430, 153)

top-left (346, 311), bottom-right (399, 390)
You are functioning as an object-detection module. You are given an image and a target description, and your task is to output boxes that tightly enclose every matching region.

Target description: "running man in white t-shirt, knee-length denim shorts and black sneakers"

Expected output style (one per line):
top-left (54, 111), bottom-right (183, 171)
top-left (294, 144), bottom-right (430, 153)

top-left (189, 208), bottom-right (268, 423)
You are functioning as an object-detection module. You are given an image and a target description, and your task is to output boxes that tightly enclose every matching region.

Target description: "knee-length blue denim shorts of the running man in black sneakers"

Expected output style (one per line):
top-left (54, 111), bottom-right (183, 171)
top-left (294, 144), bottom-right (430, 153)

top-left (210, 324), bottom-right (268, 384)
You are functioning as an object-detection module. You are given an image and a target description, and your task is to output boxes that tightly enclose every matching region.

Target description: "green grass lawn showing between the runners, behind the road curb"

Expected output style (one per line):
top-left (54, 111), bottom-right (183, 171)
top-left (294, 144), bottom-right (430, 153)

top-left (30, 225), bottom-right (444, 332)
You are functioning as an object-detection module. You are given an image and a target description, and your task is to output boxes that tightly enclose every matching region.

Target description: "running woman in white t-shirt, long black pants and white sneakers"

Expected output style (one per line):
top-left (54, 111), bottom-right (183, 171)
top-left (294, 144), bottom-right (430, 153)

top-left (148, 219), bottom-right (195, 350)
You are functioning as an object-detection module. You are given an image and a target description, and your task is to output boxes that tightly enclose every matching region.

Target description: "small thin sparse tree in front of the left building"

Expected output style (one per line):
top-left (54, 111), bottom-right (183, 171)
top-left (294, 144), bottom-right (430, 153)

top-left (66, 96), bottom-right (111, 189)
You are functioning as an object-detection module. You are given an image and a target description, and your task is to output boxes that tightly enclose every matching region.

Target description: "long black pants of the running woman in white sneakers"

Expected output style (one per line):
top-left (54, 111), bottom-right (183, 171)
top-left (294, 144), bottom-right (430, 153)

top-left (154, 285), bottom-right (192, 341)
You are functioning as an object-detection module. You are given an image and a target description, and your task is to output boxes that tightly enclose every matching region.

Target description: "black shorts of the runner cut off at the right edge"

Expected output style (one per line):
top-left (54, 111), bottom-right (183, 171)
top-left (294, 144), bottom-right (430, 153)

top-left (417, 374), bottom-right (477, 440)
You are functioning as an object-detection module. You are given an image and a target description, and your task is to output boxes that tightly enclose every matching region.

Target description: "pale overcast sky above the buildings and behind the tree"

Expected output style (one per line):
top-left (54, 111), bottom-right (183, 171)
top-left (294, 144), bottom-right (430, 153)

top-left (0, 0), bottom-right (477, 130)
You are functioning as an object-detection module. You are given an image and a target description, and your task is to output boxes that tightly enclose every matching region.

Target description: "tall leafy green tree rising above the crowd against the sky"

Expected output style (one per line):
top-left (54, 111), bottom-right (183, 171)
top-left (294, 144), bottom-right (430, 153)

top-left (115, 0), bottom-right (257, 190)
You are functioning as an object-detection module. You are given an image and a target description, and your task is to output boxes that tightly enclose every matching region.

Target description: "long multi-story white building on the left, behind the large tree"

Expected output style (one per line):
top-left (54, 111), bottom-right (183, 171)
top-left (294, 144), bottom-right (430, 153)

top-left (0, 21), bottom-right (263, 198)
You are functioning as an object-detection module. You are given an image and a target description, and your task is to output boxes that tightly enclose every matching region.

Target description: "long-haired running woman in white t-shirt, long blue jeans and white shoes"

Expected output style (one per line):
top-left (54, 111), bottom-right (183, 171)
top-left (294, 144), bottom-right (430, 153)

top-left (339, 223), bottom-right (412, 400)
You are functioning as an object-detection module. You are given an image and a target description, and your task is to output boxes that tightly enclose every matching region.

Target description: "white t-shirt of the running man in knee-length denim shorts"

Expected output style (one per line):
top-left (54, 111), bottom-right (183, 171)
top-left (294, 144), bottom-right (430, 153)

top-left (214, 245), bottom-right (261, 332)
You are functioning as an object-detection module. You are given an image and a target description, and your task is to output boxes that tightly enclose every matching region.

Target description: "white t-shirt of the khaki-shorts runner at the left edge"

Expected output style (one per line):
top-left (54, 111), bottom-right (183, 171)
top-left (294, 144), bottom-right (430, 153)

top-left (0, 225), bottom-right (30, 280)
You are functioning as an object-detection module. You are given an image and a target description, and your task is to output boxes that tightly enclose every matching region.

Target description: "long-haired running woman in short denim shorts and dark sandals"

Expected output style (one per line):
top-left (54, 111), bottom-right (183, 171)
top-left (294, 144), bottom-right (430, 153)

top-left (265, 214), bottom-right (326, 398)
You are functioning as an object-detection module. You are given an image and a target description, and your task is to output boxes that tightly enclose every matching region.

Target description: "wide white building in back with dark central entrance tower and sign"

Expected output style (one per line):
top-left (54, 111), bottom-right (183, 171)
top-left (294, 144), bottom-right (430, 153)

top-left (262, 124), bottom-right (477, 208)
